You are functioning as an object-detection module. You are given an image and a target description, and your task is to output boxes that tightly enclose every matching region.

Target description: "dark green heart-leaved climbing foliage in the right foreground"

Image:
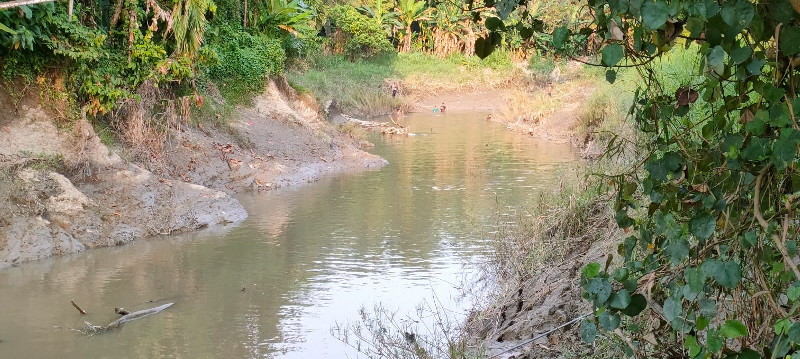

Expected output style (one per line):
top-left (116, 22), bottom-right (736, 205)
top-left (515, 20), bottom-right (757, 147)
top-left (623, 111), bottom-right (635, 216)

top-left (559, 0), bottom-right (800, 358)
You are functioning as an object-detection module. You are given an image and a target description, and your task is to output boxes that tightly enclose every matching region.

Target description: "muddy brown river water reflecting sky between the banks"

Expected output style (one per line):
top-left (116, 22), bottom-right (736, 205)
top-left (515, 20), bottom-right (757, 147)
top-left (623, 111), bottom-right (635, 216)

top-left (0, 113), bottom-right (577, 358)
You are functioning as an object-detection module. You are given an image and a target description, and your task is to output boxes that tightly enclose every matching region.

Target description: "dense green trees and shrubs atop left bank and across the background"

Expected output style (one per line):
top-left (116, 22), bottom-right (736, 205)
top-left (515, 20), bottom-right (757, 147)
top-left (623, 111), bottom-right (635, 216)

top-left (0, 0), bottom-right (580, 122)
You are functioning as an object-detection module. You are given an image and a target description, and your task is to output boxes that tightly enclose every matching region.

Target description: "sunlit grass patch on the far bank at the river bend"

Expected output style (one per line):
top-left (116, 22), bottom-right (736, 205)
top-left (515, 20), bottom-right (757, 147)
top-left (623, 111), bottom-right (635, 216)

top-left (287, 51), bottom-right (519, 116)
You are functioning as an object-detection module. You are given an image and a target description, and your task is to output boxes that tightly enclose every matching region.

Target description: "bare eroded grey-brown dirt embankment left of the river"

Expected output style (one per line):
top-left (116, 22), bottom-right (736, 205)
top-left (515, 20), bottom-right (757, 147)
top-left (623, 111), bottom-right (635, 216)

top-left (0, 82), bottom-right (385, 268)
